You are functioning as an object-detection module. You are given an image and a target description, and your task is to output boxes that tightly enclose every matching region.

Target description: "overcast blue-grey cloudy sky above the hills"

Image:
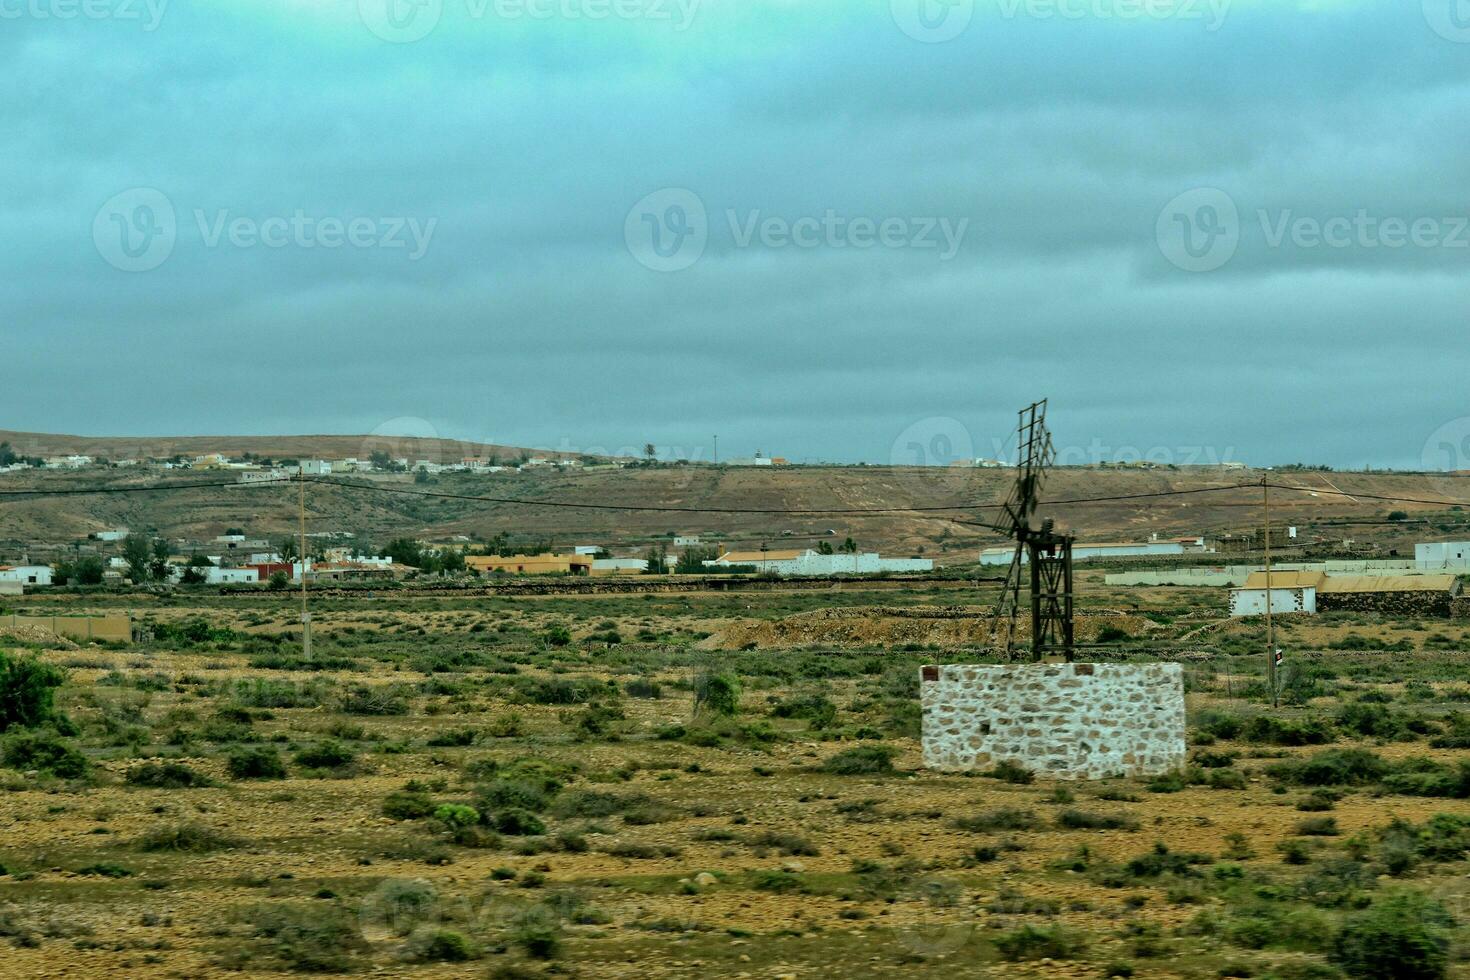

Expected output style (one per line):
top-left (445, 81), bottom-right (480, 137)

top-left (0, 0), bottom-right (1470, 467)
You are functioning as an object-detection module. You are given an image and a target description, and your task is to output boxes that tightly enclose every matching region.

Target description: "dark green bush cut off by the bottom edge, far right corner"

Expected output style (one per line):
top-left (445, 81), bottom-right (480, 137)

top-left (1329, 892), bottom-right (1454, 980)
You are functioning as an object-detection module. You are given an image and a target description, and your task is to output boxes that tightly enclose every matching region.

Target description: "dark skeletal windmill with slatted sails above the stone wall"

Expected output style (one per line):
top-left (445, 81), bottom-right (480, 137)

top-left (992, 398), bottom-right (1075, 663)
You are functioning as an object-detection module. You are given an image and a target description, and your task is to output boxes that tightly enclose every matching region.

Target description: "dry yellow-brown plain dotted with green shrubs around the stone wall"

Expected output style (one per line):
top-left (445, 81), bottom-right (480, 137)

top-left (0, 574), bottom-right (1470, 980)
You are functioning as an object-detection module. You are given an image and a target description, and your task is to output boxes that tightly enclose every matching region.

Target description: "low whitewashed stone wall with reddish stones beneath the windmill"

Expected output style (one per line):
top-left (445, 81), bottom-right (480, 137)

top-left (919, 664), bottom-right (1185, 779)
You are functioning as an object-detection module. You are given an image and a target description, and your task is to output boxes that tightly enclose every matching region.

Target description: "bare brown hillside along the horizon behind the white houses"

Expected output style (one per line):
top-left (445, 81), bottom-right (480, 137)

top-left (0, 432), bottom-right (1470, 563)
